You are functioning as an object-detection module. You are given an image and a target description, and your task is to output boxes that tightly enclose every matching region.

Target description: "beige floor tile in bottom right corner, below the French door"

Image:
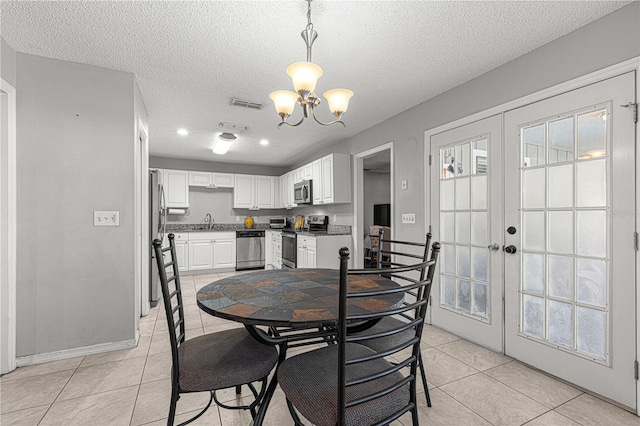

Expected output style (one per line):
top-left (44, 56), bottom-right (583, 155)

top-left (556, 394), bottom-right (640, 426)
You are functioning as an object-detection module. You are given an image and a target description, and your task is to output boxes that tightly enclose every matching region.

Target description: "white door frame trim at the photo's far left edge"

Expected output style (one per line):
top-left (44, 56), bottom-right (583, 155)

top-left (0, 79), bottom-right (17, 374)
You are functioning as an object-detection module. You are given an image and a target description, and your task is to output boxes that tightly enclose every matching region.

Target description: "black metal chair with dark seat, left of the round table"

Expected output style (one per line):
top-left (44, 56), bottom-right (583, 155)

top-left (153, 234), bottom-right (278, 426)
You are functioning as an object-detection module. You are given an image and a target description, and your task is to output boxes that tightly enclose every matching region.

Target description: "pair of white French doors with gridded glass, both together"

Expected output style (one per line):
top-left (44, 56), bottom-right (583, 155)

top-left (428, 71), bottom-right (638, 410)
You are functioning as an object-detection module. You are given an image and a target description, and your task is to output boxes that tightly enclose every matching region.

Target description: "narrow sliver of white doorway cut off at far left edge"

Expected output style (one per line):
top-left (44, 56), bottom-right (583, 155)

top-left (0, 80), bottom-right (17, 374)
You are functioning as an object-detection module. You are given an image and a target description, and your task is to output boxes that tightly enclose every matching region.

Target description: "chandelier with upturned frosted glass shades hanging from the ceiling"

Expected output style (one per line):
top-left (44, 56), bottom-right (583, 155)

top-left (269, 0), bottom-right (353, 128)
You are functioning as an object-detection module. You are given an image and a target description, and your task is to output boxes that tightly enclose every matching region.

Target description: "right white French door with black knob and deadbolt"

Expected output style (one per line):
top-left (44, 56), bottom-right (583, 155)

top-left (504, 73), bottom-right (636, 408)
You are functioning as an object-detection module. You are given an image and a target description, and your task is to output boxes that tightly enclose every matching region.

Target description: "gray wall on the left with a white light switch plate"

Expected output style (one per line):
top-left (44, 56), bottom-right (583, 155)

top-left (17, 53), bottom-right (141, 356)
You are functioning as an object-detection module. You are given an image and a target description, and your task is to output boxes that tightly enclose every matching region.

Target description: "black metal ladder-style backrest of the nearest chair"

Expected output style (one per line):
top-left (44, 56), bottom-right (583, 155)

top-left (338, 238), bottom-right (440, 425)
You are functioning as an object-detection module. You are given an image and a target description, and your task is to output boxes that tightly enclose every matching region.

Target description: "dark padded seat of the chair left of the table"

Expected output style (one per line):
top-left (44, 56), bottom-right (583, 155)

top-left (178, 328), bottom-right (278, 392)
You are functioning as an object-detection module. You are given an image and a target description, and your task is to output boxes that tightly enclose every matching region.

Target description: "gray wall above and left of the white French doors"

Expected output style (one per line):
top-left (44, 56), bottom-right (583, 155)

top-left (294, 2), bottom-right (640, 245)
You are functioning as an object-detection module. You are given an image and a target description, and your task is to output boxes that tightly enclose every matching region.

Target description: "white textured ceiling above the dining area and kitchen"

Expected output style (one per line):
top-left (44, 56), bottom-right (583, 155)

top-left (0, 0), bottom-right (629, 166)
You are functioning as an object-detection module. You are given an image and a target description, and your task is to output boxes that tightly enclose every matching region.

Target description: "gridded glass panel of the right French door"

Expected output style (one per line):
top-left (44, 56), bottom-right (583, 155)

top-left (520, 107), bottom-right (610, 362)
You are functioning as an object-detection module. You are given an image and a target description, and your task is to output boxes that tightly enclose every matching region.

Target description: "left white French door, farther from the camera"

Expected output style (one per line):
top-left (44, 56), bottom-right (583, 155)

top-left (430, 115), bottom-right (503, 352)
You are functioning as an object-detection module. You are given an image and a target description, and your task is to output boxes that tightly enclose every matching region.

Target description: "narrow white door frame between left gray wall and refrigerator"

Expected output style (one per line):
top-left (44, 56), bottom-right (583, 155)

top-left (134, 117), bottom-right (150, 330)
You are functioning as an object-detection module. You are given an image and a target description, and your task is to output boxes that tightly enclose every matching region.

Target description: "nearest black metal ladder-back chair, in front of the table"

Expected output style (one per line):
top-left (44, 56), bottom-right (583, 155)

top-left (277, 243), bottom-right (440, 426)
